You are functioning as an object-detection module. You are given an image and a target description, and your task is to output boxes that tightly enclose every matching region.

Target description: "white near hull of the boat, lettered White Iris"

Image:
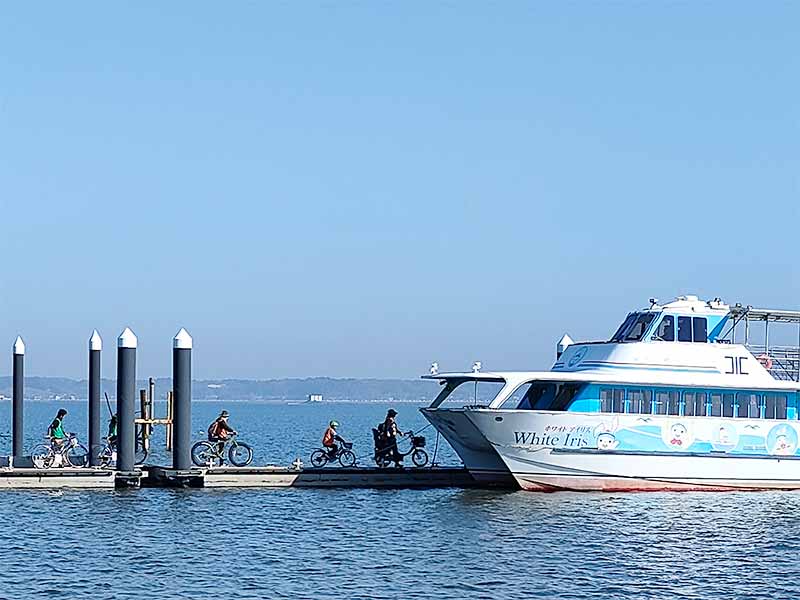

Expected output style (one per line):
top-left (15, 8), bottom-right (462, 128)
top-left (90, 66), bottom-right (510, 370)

top-left (466, 410), bottom-right (800, 492)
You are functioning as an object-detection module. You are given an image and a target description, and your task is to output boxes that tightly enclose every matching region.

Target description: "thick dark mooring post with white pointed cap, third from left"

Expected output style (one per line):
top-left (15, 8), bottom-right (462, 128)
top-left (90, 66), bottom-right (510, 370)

top-left (117, 327), bottom-right (137, 471)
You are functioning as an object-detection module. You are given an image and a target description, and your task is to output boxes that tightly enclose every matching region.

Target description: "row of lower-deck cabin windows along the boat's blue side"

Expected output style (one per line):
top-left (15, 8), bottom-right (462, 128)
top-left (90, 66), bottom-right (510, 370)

top-left (600, 388), bottom-right (788, 419)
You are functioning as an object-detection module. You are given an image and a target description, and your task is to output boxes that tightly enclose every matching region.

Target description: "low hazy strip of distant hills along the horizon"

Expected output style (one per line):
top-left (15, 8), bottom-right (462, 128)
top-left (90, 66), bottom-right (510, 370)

top-left (0, 376), bottom-right (496, 402)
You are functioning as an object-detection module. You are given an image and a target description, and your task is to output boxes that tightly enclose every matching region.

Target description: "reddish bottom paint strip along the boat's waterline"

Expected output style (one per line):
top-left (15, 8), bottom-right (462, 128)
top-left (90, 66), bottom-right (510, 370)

top-left (517, 475), bottom-right (800, 492)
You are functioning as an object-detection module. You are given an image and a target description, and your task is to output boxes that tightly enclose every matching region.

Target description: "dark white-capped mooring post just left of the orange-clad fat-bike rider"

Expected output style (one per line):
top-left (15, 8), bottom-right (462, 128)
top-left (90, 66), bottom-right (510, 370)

top-left (172, 329), bottom-right (192, 469)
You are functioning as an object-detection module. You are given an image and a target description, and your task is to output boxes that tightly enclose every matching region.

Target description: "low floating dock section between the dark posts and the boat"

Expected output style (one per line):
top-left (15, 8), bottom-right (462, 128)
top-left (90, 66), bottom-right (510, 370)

top-left (142, 466), bottom-right (477, 489)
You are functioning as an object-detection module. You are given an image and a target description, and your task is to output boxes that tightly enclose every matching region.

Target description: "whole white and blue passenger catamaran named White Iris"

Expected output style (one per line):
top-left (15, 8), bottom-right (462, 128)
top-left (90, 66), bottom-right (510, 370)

top-left (422, 296), bottom-right (800, 491)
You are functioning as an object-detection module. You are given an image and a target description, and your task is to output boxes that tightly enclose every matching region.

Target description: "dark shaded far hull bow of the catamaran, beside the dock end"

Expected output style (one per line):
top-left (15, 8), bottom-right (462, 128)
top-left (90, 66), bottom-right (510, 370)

top-left (421, 408), bottom-right (515, 486)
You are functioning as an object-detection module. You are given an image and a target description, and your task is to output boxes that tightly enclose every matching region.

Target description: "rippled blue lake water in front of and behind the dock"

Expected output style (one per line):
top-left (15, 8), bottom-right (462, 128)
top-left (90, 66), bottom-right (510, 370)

top-left (0, 402), bottom-right (800, 600)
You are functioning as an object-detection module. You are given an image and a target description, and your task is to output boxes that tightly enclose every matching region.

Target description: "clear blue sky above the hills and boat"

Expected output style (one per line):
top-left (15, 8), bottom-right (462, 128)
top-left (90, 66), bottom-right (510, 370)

top-left (0, 2), bottom-right (800, 378)
